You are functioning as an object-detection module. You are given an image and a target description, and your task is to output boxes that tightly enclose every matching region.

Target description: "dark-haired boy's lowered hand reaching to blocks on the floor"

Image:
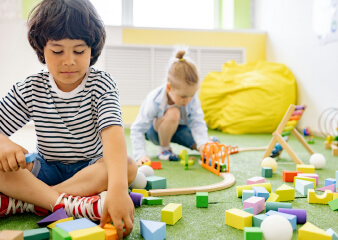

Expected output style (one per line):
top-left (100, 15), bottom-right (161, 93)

top-left (100, 191), bottom-right (135, 239)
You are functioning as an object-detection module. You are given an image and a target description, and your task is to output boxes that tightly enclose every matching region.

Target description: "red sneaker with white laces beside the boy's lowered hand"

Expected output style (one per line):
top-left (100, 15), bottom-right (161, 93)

top-left (53, 191), bottom-right (107, 221)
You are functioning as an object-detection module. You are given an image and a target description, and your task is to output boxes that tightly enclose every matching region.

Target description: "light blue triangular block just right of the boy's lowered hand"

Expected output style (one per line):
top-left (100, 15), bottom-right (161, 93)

top-left (140, 220), bottom-right (167, 240)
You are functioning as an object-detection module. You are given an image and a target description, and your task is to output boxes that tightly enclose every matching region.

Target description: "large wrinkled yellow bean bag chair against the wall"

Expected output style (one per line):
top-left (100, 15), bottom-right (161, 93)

top-left (199, 61), bottom-right (297, 134)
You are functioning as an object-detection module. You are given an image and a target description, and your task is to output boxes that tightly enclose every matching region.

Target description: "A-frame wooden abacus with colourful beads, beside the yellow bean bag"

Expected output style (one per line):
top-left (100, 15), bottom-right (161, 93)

top-left (262, 104), bottom-right (314, 164)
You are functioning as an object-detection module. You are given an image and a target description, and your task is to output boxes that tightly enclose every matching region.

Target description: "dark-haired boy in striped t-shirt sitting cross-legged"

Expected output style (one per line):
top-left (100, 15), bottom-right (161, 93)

top-left (0, 0), bottom-right (137, 238)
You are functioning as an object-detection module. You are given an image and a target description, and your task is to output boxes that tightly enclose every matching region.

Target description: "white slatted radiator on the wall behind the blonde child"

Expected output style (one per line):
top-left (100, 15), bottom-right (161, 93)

top-left (104, 45), bottom-right (246, 106)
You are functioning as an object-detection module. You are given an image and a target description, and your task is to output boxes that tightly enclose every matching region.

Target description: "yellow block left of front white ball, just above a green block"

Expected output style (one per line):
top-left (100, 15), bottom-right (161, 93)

top-left (225, 208), bottom-right (253, 230)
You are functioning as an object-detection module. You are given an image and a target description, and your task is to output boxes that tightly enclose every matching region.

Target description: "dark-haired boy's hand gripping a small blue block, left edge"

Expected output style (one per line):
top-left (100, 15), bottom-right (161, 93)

top-left (0, 134), bottom-right (28, 172)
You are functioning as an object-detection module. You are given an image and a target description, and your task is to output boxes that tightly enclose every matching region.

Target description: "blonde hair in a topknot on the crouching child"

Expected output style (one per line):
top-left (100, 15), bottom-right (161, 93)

top-left (168, 50), bottom-right (199, 85)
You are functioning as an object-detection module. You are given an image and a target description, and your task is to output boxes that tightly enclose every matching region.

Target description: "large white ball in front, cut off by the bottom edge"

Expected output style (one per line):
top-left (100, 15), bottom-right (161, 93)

top-left (261, 215), bottom-right (293, 240)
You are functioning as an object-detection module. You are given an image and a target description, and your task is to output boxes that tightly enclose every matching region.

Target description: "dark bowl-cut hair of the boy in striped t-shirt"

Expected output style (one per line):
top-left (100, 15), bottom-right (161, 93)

top-left (28, 0), bottom-right (106, 66)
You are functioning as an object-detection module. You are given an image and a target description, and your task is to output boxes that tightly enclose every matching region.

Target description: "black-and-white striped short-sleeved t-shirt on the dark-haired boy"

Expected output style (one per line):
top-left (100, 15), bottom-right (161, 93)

top-left (0, 68), bottom-right (122, 163)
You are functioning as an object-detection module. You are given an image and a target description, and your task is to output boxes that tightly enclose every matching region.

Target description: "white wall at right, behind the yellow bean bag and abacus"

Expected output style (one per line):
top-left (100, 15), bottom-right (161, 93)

top-left (254, 0), bottom-right (338, 135)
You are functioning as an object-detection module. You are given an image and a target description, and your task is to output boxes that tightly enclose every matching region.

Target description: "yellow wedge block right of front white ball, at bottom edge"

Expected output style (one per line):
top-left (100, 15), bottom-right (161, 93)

top-left (298, 222), bottom-right (332, 240)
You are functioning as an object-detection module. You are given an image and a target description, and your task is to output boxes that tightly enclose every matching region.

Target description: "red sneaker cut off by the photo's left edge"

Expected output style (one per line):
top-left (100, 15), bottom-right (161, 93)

top-left (0, 193), bottom-right (48, 217)
